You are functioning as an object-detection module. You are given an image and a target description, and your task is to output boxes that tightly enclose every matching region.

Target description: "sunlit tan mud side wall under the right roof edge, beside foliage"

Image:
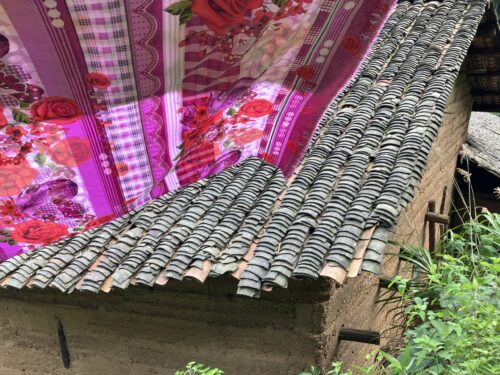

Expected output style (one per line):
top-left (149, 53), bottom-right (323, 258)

top-left (326, 73), bottom-right (472, 365)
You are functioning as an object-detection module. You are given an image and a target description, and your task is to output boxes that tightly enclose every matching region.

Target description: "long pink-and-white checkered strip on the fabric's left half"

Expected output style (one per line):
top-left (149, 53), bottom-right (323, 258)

top-left (68, 0), bottom-right (153, 199)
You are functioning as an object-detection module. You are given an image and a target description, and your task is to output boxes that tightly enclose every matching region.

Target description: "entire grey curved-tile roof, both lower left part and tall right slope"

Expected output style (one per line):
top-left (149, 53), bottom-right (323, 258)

top-left (0, 0), bottom-right (486, 296)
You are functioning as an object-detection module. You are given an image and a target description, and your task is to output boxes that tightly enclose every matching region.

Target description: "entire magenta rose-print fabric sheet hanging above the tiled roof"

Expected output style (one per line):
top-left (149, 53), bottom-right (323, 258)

top-left (0, 0), bottom-right (395, 261)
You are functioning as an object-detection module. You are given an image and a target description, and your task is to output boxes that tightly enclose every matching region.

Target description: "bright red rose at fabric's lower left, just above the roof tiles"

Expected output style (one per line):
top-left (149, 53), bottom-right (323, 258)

top-left (11, 220), bottom-right (68, 245)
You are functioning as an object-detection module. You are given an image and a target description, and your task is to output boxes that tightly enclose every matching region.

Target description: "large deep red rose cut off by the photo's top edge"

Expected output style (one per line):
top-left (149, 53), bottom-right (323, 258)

top-left (191, 0), bottom-right (262, 35)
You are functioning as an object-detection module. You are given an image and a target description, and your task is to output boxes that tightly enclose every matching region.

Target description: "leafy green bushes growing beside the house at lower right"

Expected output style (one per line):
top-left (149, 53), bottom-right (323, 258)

top-left (300, 214), bottom-right (500, 375)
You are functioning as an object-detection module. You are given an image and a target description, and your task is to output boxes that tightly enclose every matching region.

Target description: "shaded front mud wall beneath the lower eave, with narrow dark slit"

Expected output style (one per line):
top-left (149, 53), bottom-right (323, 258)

top-left (0, 278), bottom-right (329, 375)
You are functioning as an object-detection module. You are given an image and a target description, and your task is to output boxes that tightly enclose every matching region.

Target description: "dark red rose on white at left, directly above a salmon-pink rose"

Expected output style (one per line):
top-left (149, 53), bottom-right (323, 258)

top-left (30, 96), bottom-right (83, 125)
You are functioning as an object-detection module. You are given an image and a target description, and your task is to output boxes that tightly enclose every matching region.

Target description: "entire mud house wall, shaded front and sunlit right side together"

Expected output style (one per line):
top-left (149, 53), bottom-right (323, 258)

top-left (0, 77), bottom-right (471, 375)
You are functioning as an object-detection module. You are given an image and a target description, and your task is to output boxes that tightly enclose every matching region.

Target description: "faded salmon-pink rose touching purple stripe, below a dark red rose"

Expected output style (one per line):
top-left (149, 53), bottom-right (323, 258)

top-left (49, 137), bottom-right (91, 167)
